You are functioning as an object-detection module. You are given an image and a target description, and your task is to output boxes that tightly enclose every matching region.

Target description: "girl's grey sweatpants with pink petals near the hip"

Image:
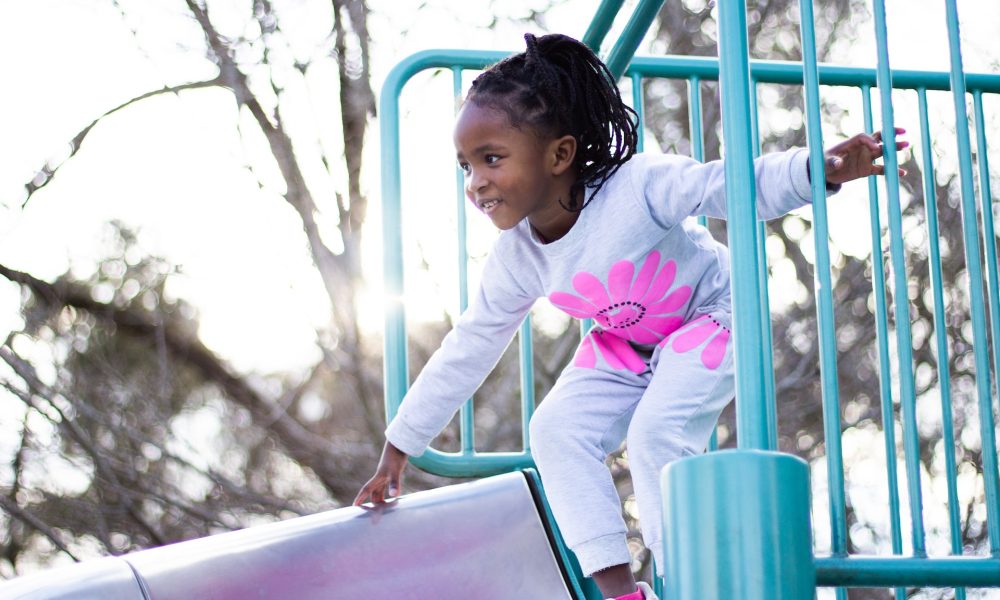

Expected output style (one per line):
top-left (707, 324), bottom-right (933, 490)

top-left (531, 314), bottom-right (735, 576)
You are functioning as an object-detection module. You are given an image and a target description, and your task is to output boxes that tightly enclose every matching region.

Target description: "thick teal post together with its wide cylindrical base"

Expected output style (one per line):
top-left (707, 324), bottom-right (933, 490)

top-left (660, 0), bottom-right (816, 600)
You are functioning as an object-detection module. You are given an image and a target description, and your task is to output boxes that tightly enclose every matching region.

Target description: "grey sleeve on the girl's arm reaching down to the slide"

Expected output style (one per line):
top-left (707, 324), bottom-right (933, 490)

top-left (385, 248), bottom-right (536, 456)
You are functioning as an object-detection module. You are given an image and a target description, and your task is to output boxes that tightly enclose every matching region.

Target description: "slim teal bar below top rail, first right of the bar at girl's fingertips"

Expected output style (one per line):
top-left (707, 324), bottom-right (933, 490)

top-left (917, 88), bottom-right (965, 600)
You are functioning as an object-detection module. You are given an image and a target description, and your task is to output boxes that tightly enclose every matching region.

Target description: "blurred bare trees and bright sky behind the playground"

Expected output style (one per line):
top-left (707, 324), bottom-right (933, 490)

top-left (0, 0), bottom-right (1000, 598)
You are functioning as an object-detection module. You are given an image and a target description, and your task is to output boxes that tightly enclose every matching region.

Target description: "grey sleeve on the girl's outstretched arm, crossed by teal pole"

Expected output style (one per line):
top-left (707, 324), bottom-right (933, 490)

top-left (633, 148), bottom-right (812, 228)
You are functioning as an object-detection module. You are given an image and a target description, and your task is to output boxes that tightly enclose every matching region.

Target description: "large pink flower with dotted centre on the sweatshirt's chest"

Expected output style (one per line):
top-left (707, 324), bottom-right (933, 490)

top-left (549, 250), bottom-right (691, 346)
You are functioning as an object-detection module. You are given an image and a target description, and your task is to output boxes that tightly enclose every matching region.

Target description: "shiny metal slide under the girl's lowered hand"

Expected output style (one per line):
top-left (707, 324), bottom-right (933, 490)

top-left (0, 472), bottom-right (576, 600)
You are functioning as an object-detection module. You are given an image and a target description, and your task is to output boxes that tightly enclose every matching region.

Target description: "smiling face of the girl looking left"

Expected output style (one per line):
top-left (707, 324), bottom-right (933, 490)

top-left (455, 102), bottom-right (577, 241)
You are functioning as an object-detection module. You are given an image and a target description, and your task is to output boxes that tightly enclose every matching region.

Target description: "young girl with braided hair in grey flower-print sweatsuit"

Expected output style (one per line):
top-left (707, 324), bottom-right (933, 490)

top-left (355, 34), bottom-right (906, 600)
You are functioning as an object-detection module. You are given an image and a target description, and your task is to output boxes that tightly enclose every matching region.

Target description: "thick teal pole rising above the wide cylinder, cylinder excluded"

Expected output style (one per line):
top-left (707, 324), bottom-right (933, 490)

top-left (719, 0), bottom-right (768, 449)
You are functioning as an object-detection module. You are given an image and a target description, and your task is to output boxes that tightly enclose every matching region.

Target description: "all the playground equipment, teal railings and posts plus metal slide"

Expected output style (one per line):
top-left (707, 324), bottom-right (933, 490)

top-left (0, 0), bottom-right (1000, 600)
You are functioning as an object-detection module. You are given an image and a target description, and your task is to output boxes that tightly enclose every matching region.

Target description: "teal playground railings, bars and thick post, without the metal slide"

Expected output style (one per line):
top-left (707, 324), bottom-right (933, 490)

top-left (381, 0), bottom-right (1000, 600)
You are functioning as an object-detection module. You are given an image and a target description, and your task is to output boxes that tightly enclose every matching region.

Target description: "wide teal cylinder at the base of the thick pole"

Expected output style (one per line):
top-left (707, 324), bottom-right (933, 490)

top-left (661, 450), bottom-right (816, 600)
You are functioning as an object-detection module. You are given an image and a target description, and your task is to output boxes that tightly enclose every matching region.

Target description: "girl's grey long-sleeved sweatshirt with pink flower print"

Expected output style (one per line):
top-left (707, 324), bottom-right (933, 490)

top-left (385, 149), bottom-right (811, 456)
